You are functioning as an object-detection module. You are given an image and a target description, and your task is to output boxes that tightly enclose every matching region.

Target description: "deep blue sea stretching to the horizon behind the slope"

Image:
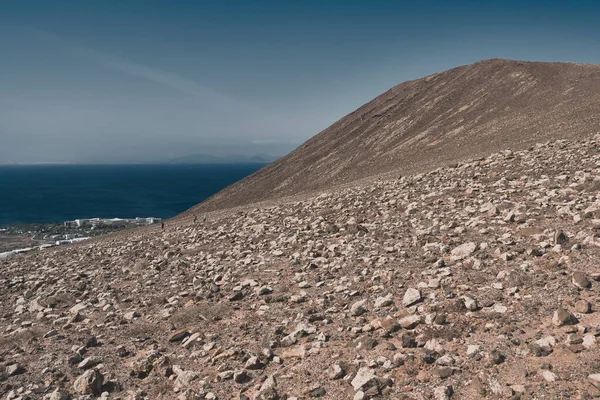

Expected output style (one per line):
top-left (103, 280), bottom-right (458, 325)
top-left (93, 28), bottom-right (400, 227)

top-left (0, 164), bottom-right (264, 226)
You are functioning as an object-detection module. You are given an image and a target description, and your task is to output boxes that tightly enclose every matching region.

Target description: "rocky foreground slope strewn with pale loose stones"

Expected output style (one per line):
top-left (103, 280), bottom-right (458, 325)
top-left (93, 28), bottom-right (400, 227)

top-left (0, 138), bottom-right (600, 400)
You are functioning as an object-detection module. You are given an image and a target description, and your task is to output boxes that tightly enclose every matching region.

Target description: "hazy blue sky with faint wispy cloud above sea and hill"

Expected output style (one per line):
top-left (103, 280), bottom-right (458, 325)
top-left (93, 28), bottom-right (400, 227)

top-left (0, 0), bottom-right (600, 164)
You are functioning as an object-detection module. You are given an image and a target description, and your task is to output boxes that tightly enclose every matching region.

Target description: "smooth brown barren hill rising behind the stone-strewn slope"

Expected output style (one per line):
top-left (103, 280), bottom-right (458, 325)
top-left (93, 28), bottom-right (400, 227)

top-left (190, 59), bottom-right (600, 211)
